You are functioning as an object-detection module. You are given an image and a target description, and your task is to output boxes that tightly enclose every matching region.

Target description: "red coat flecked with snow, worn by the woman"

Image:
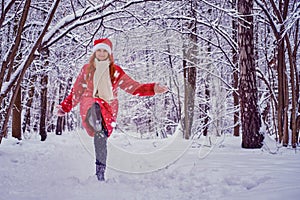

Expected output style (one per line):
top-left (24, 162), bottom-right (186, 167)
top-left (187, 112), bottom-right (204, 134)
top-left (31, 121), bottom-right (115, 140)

top-left (61, 64), bottom-right (155, 137)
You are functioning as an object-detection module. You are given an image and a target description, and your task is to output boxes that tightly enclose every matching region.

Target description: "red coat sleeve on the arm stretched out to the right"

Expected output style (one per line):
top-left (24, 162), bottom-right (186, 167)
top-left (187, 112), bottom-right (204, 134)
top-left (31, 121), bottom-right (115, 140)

top-left (115, 66), bottom-right (155, 96)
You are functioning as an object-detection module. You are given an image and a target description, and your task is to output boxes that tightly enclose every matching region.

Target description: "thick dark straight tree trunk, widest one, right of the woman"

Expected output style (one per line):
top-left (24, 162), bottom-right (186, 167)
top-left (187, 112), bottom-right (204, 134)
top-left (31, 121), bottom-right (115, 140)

top-left (238, 0), bottom-right (264, 148)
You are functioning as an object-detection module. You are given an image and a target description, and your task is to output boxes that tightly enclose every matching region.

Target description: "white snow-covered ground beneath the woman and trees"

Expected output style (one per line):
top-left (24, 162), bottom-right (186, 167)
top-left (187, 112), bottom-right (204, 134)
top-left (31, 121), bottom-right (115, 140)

top-left (0, 128), bottom-right (300, 200)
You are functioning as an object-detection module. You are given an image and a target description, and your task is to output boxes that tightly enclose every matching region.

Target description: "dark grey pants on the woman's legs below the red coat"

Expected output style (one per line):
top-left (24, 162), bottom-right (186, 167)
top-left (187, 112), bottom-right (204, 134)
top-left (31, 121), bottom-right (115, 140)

top-left (87, 103), bottom-right (107, 166)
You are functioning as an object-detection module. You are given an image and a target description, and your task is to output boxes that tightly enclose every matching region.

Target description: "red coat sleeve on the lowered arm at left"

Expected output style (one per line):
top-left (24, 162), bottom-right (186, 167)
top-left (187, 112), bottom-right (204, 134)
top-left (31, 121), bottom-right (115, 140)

top-left (60, 66), bottom-right (87, 112)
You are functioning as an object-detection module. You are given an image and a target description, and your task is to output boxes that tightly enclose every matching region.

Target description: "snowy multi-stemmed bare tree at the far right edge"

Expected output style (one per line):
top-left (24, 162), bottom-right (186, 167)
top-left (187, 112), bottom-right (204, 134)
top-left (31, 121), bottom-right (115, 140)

top-left (256, 0), bottom-right (300, 148)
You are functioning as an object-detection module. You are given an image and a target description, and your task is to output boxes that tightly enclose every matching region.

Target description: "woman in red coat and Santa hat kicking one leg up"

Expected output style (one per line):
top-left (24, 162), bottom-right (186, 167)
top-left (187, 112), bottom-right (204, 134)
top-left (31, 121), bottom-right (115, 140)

top-left (58, 38), bottom-right (168, 181)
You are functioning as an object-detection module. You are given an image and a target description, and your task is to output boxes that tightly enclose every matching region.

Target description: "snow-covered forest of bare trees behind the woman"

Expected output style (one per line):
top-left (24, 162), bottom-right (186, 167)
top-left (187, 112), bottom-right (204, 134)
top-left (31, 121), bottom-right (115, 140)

top-left (0, 0), bottom-right (300, 148)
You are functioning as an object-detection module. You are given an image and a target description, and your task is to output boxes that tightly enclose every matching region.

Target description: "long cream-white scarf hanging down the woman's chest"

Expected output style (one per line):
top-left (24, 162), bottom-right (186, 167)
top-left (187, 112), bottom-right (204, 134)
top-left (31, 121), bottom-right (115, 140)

top-left (93, 58), bottom-right (114, 103)
